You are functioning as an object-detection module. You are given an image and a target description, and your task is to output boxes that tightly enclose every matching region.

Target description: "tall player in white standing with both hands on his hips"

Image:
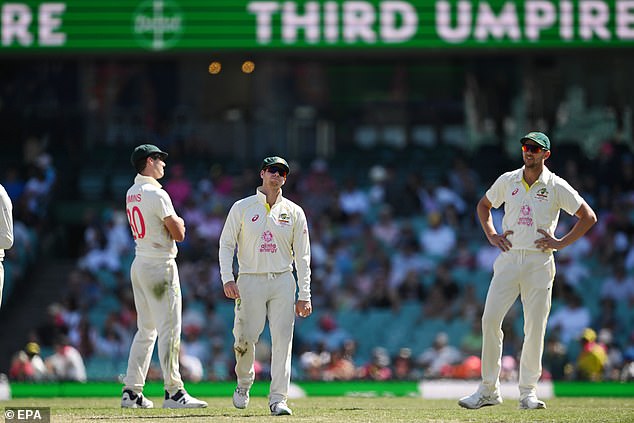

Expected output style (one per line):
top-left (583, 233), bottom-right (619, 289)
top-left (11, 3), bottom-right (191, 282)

top-left (458, 132), bottom-right (597, 409)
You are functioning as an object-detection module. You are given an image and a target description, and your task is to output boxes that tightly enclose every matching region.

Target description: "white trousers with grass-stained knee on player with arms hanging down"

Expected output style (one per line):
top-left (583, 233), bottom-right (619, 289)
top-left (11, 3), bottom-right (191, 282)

top-left (233, 272), bottom-right (296, 404)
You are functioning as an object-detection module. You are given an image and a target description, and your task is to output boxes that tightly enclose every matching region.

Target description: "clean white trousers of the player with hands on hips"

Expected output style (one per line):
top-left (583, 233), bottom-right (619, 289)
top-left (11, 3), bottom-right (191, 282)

top-left (480, 250), bottom-right (555, 399)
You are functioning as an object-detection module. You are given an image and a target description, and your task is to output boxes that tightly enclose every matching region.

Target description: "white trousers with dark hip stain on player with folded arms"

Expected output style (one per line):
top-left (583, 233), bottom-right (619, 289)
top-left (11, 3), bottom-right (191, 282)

top-left (123, 257), bottom-right (183, 395)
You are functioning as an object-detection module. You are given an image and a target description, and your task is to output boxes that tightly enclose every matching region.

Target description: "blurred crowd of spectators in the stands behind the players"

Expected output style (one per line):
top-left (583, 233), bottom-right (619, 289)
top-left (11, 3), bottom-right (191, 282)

top-left (3, 137), bottom-right (634, 386)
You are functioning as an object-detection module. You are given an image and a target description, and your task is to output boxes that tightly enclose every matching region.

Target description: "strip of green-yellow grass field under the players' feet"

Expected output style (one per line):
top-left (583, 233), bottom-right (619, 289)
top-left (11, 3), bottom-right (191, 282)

top-left (0, 396), bottom-right (634, 423)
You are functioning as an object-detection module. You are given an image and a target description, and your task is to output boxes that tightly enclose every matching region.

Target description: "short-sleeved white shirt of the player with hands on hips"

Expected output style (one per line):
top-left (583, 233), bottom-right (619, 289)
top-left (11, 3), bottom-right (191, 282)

top-left (486, 166), bottom-right (583, 251)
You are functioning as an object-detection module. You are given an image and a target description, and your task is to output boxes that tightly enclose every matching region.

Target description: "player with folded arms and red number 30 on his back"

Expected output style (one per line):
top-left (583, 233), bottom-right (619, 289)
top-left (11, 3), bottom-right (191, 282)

top-left (121, 144), bottom-right (207, 408)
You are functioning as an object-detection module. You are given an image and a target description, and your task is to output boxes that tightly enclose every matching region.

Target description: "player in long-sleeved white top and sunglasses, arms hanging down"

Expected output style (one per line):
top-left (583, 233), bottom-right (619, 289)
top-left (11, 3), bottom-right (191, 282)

top-left (219, 157), bottom-right (312, 415)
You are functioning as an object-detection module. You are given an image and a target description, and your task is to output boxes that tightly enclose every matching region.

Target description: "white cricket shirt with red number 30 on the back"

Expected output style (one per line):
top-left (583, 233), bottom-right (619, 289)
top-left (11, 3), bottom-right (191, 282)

top-left (126, 175), bottom-right (178, 258)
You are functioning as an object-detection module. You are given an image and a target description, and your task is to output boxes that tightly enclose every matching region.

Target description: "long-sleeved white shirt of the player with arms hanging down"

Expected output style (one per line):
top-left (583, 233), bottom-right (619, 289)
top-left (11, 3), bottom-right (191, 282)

top-left (218, 188), bottom-right (310, 300)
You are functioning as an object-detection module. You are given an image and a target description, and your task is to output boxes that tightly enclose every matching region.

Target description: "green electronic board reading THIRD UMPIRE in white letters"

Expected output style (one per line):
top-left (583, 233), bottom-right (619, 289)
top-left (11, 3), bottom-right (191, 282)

top-left (0, 0), bottom-right (634, 54)
